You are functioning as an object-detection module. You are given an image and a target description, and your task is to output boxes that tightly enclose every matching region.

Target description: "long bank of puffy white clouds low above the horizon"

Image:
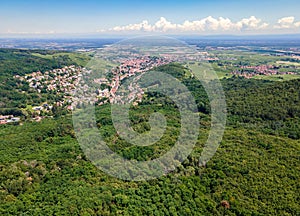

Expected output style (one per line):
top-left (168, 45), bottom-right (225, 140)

top-left (100, 16), bottom-right (300, 33)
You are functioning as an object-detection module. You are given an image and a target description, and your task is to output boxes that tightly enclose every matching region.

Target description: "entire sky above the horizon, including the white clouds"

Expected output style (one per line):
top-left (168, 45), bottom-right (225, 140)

top-left (0, 0), bottom-right (300, 35)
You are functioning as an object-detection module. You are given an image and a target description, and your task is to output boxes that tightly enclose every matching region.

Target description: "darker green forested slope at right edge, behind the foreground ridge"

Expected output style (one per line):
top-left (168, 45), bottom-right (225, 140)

top-left (222, 78), bottom-right (300, 139)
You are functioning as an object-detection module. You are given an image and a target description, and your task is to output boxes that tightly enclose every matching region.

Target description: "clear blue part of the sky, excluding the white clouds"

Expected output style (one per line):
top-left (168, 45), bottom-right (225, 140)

top-left (0, 0), bottom-right (300, 34)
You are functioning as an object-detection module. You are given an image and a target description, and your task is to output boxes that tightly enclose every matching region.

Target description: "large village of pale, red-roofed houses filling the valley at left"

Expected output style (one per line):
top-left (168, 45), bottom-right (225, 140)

top-left (12, 56), bottom-right (171, 124)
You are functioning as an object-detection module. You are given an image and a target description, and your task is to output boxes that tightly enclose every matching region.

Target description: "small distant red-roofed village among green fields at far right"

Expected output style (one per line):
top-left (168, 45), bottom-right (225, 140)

top-left (231, 65), bottom-right (296, 79)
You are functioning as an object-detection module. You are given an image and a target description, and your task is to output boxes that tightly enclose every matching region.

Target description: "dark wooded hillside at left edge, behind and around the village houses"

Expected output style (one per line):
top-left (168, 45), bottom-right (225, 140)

top-left (0, 49), bottom-right (90, 113)
